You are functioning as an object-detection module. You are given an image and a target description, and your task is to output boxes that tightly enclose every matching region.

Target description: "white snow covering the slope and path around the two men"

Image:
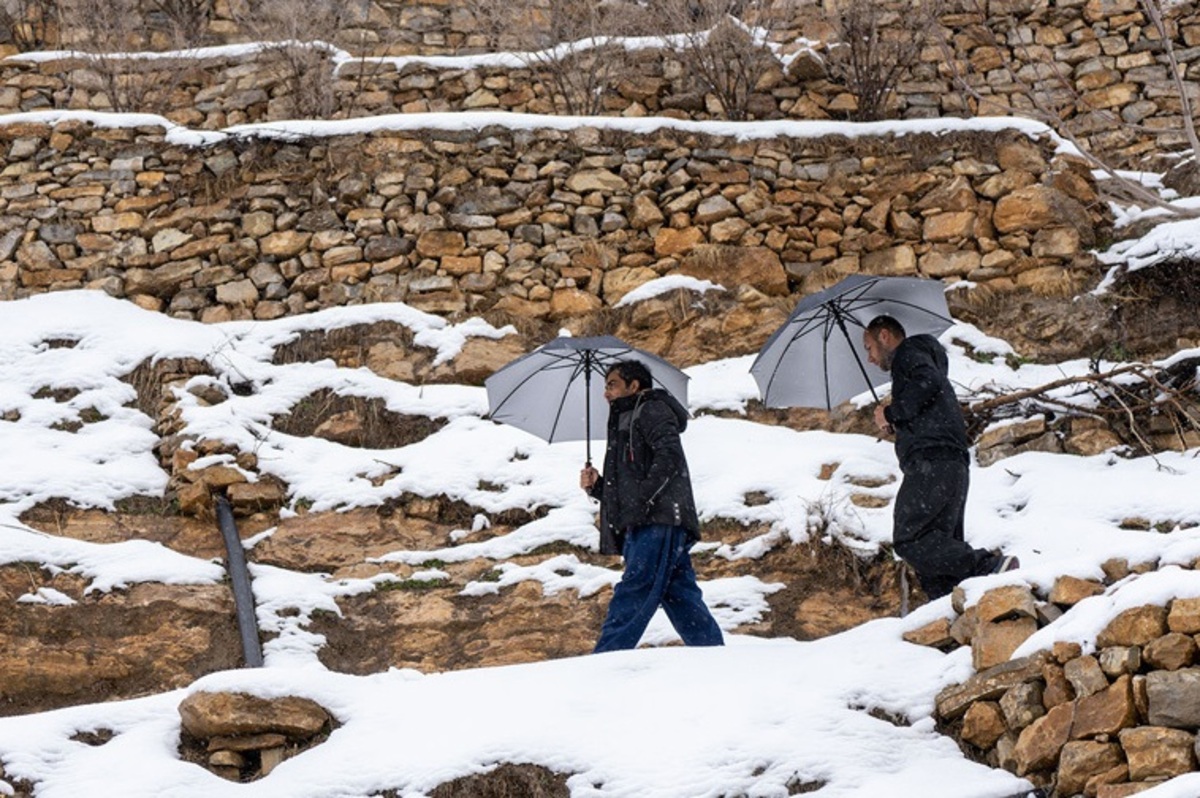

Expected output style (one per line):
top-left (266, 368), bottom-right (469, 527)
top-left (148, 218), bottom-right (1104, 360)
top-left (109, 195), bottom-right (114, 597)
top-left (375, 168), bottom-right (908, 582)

top-left (0, 283), bottom-right (1200, 798)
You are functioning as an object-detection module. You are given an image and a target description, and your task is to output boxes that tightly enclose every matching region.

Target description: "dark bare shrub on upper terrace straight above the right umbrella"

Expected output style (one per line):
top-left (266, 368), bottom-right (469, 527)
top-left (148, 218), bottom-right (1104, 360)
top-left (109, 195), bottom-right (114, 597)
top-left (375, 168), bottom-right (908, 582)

top-left (828, 0), bottom-right (934, 121)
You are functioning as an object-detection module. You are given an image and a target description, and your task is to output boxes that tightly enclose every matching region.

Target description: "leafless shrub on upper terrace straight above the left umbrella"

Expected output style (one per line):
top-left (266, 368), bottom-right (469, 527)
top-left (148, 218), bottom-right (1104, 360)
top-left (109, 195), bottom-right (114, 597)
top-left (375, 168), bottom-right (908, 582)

top-left (473, 0), bottom-right (636, 115)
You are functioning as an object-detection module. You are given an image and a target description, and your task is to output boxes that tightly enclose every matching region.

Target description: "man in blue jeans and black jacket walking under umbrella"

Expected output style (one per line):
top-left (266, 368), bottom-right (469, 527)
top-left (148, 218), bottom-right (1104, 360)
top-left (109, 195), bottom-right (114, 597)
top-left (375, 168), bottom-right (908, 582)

top-left (580, 360), bottom-right (724, 653)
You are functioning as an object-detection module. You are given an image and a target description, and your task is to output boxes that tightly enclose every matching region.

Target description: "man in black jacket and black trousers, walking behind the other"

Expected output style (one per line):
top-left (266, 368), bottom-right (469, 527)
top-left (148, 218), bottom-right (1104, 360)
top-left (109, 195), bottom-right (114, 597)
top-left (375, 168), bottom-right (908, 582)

top-left (863, 316), bottom-right (1020, 599)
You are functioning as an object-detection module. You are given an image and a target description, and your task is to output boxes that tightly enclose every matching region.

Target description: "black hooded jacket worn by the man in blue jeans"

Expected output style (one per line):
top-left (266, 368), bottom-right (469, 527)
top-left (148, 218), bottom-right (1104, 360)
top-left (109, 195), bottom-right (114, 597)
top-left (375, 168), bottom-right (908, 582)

top-left (592, 388), bottom-right (700, 554)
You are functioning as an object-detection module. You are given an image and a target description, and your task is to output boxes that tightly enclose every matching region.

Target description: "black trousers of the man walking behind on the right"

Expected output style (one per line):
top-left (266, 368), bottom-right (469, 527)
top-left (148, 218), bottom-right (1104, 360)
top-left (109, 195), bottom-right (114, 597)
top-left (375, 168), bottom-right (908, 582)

top-left (892, 458), bottom-right (998, 599)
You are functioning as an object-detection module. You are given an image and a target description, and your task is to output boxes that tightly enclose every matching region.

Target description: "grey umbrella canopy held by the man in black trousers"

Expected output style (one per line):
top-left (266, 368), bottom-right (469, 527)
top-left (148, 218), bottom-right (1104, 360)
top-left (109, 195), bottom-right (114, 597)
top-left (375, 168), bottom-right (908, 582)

top-left (750, 275), bottom-right (954, 410)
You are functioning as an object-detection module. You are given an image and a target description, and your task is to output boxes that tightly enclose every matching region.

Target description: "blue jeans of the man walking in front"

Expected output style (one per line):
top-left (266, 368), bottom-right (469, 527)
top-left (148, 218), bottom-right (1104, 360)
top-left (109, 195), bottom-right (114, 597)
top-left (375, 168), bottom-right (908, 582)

top-left (594, 524), bottom-right (725, 654)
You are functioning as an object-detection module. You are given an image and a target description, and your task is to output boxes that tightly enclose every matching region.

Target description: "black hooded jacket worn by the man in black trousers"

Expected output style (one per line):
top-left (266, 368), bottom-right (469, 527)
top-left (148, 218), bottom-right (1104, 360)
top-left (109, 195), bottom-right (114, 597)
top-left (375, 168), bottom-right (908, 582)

top-left (883, 335), bottom-right (971, 470)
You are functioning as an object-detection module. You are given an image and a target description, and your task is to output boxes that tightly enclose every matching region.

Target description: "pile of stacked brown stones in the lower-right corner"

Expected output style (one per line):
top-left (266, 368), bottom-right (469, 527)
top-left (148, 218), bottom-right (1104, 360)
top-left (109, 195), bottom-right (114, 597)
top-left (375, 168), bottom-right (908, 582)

top-left (906, 560), bottom-right (1200, 798)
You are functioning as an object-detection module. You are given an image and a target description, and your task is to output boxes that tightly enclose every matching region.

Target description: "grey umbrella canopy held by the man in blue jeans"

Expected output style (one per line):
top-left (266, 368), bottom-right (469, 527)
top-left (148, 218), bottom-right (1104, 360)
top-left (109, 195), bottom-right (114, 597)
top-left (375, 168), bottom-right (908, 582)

top-left (484, 335), bottom-right (688, 462)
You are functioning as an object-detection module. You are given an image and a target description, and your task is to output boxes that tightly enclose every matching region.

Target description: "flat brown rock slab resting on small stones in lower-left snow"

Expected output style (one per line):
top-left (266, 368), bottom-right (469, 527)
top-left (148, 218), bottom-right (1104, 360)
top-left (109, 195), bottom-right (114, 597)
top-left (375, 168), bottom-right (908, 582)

top-left (179, 692), bottom-right (330, 739)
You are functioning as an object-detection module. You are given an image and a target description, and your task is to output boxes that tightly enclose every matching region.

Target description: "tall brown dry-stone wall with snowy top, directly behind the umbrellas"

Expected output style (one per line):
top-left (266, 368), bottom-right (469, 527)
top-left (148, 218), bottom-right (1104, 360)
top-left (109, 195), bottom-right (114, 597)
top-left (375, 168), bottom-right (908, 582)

top-left (0, 119), bottom-right (1106, 322)
